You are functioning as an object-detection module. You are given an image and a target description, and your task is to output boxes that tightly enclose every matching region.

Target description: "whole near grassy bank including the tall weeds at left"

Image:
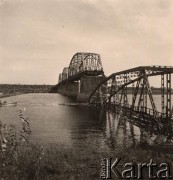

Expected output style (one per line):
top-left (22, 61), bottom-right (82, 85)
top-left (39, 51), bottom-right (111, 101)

top-left (0, 111), bottom-right (173, 180)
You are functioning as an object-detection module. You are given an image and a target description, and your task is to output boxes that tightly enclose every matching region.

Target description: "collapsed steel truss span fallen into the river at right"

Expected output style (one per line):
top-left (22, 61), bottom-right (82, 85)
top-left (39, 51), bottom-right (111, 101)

top-left (89, 66), bottom-right (173, 138)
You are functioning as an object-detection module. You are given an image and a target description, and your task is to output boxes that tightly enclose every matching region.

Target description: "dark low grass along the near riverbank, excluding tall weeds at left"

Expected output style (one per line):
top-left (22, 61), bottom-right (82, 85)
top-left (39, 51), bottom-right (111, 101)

top-left (0, 144), bottom-right (173, 180)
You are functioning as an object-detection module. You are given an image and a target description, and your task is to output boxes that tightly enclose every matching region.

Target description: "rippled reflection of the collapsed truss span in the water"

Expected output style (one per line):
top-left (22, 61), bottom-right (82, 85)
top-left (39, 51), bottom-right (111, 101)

top-left (101, 109), bottom-right (166, 149)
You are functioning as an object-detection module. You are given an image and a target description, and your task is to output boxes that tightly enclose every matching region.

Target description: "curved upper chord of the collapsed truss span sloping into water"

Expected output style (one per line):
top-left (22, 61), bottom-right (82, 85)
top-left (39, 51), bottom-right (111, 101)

top-left (89, 66), bottom-right (173, 103)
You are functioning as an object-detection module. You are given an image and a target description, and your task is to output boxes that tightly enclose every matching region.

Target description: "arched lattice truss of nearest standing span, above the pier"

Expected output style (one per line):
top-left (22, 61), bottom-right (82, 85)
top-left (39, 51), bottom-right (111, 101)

top-left (68, 53), bottom-right (103, 77)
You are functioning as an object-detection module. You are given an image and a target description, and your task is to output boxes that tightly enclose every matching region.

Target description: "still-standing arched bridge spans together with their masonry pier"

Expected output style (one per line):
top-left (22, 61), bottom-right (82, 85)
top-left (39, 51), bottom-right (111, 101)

top-left (51, 52), bottom-right (105, 102)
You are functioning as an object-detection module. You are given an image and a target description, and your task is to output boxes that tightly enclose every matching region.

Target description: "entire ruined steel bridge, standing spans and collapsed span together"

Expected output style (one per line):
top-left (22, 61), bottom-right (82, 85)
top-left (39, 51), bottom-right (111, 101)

top-left (51, 53), bottom-right (173, 139)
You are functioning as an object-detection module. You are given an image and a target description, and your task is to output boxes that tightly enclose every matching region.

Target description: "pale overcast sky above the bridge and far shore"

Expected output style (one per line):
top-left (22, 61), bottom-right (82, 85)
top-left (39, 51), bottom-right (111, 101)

top-left (0, 0), bottom-right (173, 84)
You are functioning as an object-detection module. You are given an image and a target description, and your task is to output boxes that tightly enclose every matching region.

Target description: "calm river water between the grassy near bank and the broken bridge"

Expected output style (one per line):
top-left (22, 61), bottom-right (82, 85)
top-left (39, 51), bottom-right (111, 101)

top-left (0, 94), bottom-right (172, 150)
